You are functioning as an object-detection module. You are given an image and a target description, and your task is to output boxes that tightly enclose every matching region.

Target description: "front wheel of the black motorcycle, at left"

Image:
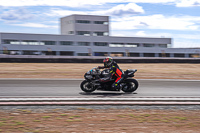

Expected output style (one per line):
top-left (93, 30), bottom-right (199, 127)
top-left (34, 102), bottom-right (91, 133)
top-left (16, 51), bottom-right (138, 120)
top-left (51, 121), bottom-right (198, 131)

top-left (80, 80), bottom-right (95, 92)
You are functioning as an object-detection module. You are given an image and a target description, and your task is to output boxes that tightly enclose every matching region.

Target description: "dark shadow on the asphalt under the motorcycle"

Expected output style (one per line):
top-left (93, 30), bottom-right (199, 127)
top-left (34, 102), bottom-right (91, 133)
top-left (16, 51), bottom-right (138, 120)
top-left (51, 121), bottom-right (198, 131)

top-left (79, 92), bottom-right (137, 97)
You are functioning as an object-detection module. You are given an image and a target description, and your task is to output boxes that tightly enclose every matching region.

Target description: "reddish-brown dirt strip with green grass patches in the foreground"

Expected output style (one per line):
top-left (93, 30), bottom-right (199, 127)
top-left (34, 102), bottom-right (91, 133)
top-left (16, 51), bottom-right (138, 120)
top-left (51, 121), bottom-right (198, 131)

top-left (0, 109), bottom-right (200, 133)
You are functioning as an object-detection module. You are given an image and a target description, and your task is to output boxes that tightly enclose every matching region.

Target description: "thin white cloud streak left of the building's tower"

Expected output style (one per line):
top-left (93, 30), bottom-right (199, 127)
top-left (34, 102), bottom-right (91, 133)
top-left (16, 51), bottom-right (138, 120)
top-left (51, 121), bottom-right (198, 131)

top-left (12, 23), bottom-right (58, 28)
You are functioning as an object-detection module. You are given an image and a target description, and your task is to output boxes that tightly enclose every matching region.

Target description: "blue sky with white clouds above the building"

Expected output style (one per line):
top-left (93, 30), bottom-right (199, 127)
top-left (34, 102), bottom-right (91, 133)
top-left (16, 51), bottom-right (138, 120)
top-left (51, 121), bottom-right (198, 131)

top-left (0, 0), bottom-right (200, 48)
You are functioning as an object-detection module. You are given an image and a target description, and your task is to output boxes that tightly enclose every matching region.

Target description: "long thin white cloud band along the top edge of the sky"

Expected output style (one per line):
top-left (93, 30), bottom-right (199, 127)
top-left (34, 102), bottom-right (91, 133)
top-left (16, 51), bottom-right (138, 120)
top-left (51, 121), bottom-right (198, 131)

top-left (0, 0), bottom-right (180, 7)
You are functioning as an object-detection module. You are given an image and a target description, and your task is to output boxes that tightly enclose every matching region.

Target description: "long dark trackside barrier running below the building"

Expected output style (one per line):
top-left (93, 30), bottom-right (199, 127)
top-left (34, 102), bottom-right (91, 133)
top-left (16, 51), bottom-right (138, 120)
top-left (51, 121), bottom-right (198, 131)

top-left (0, 55), bottom-right (200, 63)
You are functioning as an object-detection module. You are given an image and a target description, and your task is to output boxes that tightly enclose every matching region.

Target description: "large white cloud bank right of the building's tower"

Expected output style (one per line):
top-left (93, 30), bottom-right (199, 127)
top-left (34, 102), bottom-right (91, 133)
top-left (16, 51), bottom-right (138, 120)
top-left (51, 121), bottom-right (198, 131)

top-left (111, 14), bottom-right (200, 30)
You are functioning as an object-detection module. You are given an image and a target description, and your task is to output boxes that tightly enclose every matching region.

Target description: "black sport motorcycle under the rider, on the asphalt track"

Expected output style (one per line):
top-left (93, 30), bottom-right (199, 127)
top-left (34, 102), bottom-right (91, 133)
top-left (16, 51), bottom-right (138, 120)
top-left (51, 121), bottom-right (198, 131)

top-left (80, 67), bottom-right (139, 93)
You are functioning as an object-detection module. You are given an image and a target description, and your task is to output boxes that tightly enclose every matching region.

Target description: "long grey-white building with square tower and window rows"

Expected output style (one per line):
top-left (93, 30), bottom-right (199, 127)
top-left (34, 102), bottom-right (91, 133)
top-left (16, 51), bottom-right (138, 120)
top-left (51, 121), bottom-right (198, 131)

top-left (0, 15), bottom-right (200, 58)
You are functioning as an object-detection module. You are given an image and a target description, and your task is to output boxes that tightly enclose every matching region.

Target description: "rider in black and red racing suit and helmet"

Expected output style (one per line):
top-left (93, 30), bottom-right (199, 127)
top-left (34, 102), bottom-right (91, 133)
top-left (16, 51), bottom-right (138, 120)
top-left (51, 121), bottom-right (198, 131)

top-left (98, 57), bottom-right (124, 90)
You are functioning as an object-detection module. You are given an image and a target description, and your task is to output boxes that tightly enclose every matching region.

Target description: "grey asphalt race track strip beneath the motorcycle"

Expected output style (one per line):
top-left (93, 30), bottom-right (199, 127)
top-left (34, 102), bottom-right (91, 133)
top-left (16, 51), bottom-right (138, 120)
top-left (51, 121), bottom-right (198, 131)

top-left (0, 79), bottom-right (200, 97)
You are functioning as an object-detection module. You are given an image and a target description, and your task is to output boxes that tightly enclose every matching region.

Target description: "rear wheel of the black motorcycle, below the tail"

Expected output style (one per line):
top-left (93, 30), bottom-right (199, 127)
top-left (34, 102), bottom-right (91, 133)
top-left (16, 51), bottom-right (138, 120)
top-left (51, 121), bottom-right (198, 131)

top-left (122, 79), bottom-right (139, 92)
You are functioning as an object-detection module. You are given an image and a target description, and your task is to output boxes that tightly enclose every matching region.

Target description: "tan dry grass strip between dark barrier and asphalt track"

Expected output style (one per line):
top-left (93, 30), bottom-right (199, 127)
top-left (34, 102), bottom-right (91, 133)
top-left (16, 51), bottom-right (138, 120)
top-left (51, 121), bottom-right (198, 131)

top-left (0, 63), bottom-right (200, 80)
